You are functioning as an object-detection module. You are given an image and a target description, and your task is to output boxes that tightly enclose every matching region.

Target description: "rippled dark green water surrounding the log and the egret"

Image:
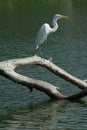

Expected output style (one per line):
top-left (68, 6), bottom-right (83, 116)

top-left (0, 0), bottom-right (87, 130)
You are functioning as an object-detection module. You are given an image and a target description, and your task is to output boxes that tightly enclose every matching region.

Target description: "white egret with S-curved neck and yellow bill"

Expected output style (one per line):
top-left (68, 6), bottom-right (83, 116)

top-left (35, 14), bottom-right (68, 49)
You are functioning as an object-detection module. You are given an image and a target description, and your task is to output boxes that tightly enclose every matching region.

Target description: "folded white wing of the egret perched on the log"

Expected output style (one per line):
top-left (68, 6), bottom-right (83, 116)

top-left (35, 23), bottom-right (49, 49)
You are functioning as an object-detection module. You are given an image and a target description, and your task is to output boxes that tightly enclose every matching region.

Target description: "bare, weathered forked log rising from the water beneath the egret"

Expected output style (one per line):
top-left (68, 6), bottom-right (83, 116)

top-left (0, 55), bottom-right (87, 99)
